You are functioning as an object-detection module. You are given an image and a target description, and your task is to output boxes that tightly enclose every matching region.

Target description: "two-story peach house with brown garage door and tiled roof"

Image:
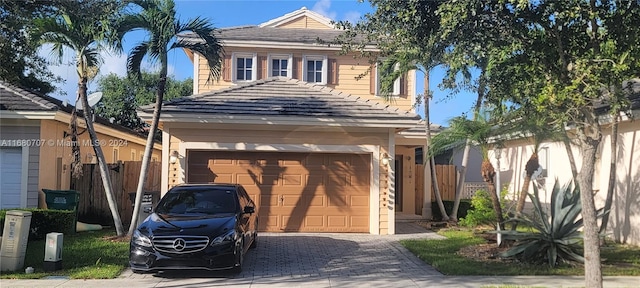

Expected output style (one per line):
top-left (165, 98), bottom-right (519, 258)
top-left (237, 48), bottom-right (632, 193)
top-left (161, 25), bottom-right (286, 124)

top-left (139, 8), bottom-right (425, 234)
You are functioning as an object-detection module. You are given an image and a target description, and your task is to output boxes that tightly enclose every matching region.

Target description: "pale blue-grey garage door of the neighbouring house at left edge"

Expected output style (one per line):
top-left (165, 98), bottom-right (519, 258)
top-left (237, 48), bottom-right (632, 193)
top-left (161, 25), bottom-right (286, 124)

top-left (0, 147), bottom-right (22, 209)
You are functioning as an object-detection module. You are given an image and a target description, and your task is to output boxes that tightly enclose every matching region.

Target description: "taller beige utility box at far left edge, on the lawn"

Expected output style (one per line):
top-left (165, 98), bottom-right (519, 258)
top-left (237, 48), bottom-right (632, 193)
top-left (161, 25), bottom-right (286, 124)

top-left (0, 210), bottom-right (31, 271)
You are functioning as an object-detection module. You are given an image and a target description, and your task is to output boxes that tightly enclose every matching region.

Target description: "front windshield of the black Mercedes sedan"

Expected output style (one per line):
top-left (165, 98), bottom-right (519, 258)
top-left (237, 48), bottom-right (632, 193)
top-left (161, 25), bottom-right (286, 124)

top-left (156, 187), bottom-right (237, 214)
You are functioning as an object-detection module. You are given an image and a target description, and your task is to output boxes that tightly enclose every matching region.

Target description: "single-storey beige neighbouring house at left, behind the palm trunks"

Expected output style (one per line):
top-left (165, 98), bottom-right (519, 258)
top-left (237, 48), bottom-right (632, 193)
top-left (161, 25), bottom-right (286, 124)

top-left (0, 80), bottom-right (161, 209)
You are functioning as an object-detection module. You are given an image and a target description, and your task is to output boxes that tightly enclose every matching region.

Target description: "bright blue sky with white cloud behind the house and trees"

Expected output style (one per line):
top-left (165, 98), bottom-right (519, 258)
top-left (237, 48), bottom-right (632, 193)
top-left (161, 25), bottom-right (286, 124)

top-left (45, 0), bottom-right (475, 126)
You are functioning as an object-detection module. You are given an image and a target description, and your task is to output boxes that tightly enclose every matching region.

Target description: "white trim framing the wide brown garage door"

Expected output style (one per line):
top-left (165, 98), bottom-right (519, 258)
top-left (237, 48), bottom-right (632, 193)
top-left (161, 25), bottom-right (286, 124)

top-left (176, 142), bottom-right (384, 234)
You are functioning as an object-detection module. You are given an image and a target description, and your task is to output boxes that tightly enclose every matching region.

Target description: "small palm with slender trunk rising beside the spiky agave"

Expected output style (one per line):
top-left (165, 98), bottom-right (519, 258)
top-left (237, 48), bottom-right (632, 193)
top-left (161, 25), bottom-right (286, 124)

top-left (429, 112), bottom-right (504, 230)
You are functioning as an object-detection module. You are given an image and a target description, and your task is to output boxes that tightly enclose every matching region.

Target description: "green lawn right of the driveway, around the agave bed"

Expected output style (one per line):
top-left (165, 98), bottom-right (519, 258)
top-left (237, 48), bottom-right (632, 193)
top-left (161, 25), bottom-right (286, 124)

top-left (401, 230), bottom-right (640, 276)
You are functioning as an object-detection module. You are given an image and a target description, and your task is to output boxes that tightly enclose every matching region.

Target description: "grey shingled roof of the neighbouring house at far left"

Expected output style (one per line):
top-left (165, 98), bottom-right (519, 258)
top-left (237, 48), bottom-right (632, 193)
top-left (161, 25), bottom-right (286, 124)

top-left (0, 79), bottom-right (71, 111)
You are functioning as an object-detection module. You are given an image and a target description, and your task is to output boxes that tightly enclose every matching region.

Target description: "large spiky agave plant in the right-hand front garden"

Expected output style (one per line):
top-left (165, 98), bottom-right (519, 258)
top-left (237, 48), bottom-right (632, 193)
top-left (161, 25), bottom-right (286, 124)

top-left (497, 180), bottom-right (584, 267)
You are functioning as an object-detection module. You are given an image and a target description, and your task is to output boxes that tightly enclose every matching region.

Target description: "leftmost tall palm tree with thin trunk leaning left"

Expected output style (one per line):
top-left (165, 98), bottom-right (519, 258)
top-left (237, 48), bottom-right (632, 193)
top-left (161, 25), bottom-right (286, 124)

top-left (34, 1), bottom-right (124, 236)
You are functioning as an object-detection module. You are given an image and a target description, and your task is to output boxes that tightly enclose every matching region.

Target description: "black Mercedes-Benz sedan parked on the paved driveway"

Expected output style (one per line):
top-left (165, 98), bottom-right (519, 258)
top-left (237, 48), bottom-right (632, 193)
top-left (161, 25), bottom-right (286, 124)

top-left (129, 184), bottom-right (258, 273)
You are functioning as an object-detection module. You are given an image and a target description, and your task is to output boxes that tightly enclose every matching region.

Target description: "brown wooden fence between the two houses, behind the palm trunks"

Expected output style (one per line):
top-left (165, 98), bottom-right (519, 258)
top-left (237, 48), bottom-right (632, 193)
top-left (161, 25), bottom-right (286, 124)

top-left (71, 161), bottom-right (162, 226)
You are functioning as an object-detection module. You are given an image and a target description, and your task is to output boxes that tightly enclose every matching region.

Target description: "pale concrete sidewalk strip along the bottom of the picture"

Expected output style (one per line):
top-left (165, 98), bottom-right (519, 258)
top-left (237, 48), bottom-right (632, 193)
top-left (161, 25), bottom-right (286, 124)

top-left (0, 272), bottom-right (640, 288)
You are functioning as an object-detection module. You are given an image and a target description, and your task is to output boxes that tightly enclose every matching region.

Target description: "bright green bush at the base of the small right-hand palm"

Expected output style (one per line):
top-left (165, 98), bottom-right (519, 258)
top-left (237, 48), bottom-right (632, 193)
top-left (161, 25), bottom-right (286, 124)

top-left (458, 190), bottom-right (507, 227)
